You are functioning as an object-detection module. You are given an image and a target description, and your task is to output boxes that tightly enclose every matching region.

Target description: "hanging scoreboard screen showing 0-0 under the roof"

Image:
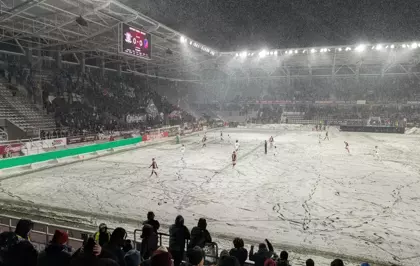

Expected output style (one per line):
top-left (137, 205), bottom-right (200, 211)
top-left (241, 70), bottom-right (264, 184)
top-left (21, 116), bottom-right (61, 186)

top-left (120, 23), bottom-right (152, 59)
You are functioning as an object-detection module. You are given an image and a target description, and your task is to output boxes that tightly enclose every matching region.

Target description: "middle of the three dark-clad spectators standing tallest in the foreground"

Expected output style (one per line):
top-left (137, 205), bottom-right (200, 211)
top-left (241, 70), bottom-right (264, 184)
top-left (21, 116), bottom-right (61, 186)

top-left (169, 215), bottom-right (190, 266)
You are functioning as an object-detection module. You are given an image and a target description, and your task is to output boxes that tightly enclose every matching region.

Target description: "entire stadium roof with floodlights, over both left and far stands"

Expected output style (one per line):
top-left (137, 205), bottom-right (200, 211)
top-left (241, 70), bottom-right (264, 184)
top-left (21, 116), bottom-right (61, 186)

top-left (0, 0), bottom-right (420, 82)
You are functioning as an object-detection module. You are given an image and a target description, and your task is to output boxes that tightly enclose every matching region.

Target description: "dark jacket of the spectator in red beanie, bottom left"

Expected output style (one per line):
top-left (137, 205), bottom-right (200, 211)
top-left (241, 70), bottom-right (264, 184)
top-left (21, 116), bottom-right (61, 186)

top-left (38, 244), bottom-right (71, 266)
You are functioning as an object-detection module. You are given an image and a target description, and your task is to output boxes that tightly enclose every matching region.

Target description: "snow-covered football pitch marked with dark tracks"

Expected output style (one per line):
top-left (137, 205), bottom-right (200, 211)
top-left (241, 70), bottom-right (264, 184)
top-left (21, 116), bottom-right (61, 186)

top-left (0, 126), bottom-right (420, 265)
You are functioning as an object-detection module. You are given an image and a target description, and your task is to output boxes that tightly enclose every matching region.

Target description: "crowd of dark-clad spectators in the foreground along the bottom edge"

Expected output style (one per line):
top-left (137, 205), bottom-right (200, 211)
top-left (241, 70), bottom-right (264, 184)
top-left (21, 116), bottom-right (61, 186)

top-left (0, 212), bottom-right (369, 266)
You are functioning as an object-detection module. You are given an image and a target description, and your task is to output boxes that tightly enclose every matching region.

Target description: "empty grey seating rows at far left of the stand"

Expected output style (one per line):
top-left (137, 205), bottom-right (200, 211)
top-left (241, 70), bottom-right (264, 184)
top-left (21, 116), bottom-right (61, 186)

top-left (0, 83), bottom-right (55, 136)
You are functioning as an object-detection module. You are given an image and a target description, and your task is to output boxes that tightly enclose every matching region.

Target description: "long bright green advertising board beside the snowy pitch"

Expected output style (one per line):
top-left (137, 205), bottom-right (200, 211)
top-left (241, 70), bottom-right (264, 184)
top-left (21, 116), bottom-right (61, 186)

top-left (0, 137), bottom-right (142, 169)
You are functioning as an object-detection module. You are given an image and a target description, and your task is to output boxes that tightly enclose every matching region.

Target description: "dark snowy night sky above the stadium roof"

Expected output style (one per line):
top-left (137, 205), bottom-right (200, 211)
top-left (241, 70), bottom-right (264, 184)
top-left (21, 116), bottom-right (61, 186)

top-left (121, 0), bottom-right (420, 51)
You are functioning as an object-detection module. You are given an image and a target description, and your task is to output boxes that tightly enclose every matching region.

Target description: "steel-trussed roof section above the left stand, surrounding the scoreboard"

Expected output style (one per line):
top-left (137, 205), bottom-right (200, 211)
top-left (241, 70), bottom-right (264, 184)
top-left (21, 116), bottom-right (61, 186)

top-left (0, 0), bottom-right (217, 78)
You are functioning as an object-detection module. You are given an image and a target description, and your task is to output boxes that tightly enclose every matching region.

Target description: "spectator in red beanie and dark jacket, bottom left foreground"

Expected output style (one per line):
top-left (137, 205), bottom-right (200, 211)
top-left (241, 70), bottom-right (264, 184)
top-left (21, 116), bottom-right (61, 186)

top-left (38, 230), bottom-right (71, 266)
